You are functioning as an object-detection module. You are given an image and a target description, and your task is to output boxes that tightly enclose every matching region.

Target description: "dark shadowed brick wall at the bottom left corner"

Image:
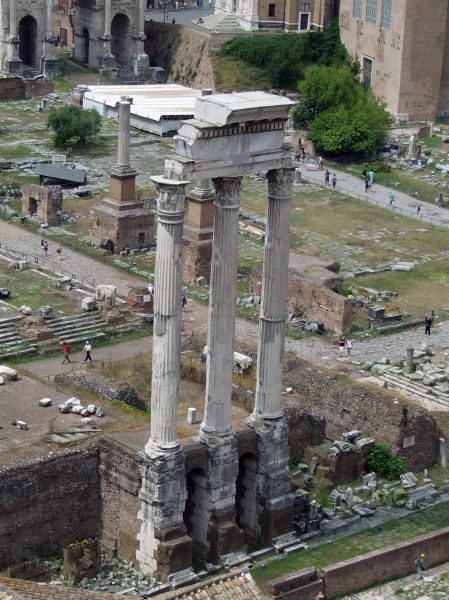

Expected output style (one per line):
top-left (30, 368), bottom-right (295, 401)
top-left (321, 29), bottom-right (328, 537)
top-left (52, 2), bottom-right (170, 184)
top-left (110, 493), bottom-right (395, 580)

top-left (0, 446), bottom-right (100, 565)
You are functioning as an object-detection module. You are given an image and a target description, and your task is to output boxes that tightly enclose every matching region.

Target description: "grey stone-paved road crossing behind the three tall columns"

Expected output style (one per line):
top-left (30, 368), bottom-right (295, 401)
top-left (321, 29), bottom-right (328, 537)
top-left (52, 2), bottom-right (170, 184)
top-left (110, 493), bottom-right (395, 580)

top-left (0, 220), bottom-right (449, 367)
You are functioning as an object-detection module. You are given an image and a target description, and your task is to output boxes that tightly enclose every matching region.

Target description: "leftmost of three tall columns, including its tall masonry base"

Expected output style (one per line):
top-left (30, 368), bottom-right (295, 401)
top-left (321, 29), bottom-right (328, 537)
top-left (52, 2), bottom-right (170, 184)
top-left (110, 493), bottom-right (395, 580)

top-left (137, 177), bottom-right (192, 580)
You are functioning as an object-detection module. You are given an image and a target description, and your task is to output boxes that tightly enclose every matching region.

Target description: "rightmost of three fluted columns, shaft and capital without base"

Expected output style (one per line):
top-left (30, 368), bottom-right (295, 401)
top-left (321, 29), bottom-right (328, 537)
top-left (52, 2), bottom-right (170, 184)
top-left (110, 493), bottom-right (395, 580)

top-left (254, 169), bottom-right (294, 419)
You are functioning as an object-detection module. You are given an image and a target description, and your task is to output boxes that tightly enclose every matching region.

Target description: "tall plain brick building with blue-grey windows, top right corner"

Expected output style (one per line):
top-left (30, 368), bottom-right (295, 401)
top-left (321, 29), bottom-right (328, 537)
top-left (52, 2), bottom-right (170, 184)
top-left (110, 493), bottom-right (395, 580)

top-left (340, 0), bottom-right (449, 121)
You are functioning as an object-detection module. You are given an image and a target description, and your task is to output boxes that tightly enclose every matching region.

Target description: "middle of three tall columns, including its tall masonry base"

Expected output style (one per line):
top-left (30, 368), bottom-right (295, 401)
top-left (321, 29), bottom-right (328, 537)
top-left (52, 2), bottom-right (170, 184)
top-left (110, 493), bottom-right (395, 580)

top-left (195, 177), bottom-right (243, 563)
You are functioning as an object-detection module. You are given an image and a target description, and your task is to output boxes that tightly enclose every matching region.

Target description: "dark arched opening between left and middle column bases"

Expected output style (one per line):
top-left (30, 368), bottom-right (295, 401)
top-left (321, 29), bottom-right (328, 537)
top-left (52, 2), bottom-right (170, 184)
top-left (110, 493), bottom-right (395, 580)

top-left (184, 469), bottom-right (209, 561)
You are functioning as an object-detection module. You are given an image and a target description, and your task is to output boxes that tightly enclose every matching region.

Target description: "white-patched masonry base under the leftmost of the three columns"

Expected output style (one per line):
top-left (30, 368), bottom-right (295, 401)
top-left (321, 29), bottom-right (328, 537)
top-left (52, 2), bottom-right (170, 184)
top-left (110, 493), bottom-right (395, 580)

top-left (136, 445), bottom-right (192, 581)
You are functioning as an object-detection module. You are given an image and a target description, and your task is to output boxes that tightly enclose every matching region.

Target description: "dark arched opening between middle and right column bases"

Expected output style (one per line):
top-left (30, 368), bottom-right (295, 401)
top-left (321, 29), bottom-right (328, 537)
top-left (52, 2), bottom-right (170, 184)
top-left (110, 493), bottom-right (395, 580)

top-left (235, 453), bottom-right (259, 542)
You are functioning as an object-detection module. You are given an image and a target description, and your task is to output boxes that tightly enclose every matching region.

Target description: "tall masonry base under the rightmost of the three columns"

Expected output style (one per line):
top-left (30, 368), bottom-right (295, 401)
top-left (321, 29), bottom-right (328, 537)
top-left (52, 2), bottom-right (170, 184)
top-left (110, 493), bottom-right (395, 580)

top-left (245, 416), bottom-right (295, 546)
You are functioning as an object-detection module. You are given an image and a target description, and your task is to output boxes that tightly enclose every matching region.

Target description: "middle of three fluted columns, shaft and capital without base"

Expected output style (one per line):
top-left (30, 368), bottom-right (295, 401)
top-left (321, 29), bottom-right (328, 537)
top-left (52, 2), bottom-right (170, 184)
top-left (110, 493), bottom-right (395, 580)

top-left (201, 177), bottom-right (242, 434)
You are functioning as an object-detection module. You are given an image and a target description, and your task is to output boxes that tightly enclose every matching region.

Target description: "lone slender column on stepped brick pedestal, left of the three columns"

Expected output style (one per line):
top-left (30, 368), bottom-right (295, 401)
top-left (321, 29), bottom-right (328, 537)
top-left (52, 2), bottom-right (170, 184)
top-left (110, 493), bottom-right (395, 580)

top-left (90, 96), bottom-right (154, 252)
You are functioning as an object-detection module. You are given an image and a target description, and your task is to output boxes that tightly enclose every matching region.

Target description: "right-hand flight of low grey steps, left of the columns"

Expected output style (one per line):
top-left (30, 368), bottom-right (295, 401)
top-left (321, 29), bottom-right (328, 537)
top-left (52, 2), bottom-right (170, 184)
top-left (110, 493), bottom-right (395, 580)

top-left (46, 313), bottom-right (106, 344)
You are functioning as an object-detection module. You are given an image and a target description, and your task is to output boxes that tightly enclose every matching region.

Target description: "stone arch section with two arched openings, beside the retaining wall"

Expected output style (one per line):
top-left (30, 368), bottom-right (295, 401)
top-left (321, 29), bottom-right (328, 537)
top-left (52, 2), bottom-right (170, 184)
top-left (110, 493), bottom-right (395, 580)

top-left (74, 0), bottom-right (149, 80)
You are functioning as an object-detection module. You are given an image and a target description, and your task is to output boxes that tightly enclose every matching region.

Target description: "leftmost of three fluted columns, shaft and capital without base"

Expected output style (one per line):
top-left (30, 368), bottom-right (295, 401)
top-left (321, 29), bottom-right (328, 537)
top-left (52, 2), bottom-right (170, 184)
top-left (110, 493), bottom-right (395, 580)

top-left (149, 177), bottom-right (186, 448)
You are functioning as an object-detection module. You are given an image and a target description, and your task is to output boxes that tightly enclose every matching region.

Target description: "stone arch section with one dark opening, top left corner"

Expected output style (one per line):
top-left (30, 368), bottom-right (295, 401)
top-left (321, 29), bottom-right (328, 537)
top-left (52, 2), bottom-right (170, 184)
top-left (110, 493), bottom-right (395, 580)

top-left (0, 0), bottom-right (58, 77)
